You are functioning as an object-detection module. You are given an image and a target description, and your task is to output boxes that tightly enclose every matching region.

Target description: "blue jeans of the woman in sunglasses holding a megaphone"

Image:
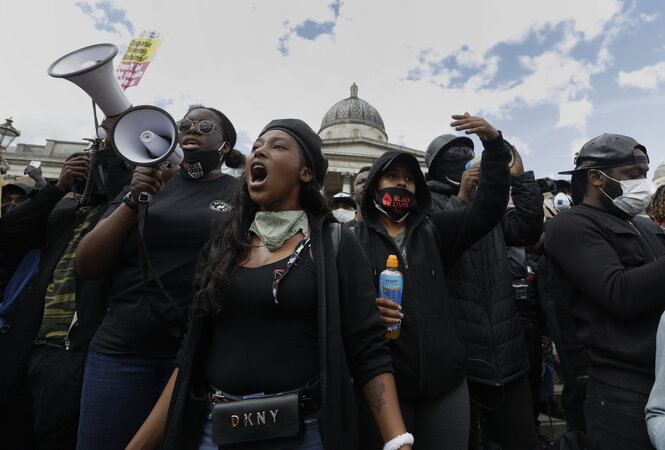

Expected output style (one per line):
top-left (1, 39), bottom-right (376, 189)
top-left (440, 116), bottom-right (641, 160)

top-left (77, 350), bottom-right (175, 450)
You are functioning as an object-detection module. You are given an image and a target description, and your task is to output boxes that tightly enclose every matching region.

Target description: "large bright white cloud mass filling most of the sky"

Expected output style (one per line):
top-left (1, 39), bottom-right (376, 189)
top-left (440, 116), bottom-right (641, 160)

top-left (0, 0), bottom-right (644, 181)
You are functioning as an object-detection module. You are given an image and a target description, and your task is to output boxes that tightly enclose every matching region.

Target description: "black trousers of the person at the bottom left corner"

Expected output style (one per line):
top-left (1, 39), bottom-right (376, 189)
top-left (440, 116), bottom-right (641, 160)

top-left (0, 345), bottom-right (85, 450)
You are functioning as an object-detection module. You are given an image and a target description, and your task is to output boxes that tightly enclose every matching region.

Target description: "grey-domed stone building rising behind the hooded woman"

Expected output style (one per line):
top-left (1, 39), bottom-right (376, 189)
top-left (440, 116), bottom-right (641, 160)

top-left (319, 83), bottom-right (427, 194)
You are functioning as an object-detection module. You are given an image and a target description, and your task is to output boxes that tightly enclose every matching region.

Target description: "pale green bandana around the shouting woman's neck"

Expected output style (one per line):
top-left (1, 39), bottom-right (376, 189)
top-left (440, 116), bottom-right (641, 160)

top-left (249, 210), bottom-right (309, 252)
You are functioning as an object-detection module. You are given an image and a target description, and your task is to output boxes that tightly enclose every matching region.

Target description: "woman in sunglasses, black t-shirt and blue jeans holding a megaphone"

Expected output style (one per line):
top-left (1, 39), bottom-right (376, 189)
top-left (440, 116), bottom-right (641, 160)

top-left (76, 106), bottom-right (237, 450)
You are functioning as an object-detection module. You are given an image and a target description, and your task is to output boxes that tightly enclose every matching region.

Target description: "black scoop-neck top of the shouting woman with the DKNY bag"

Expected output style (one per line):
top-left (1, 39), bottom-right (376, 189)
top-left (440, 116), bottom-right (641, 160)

top-left (205, 249), bottom-right (319, 395)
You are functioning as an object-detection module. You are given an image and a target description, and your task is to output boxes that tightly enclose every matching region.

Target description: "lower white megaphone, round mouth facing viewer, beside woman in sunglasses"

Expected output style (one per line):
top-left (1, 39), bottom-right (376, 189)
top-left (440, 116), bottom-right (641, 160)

top-left (111, 105), bottom-right (185, 166)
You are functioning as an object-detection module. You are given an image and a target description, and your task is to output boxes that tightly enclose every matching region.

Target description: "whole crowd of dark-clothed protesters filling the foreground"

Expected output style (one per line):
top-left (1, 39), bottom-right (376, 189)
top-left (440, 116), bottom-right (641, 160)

top-left (0, 105), bottom-right (665, 450)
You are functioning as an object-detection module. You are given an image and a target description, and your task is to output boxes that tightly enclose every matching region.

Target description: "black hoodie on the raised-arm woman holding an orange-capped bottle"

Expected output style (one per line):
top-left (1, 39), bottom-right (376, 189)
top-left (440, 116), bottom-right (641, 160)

top-left (354, 137), bottom-right (510, 399)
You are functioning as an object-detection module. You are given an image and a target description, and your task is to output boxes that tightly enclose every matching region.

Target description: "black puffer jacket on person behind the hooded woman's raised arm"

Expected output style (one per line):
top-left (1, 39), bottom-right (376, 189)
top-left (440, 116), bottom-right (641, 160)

top-left (428, 171), bottom-right (543, 385)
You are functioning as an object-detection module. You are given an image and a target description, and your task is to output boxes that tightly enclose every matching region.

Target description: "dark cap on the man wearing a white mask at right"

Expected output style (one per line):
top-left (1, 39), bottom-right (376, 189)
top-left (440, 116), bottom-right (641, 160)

top-left (559, 133), bottom-right (649, 174)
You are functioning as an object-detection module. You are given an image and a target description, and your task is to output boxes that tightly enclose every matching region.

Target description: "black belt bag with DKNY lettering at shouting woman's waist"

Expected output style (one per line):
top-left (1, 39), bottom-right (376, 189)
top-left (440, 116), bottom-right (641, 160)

top-left (212, 391), bottom-right (310, 450)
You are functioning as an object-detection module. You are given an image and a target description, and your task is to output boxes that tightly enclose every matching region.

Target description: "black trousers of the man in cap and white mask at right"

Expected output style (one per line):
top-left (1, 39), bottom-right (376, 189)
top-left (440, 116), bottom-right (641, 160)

top-left (584, 379), bottom-right (653, 450)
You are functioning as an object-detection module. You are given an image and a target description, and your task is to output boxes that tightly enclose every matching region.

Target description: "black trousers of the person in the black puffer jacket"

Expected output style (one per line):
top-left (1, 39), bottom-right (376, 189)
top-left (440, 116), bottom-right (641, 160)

top-left (469, 375), bottom-right (538, 450)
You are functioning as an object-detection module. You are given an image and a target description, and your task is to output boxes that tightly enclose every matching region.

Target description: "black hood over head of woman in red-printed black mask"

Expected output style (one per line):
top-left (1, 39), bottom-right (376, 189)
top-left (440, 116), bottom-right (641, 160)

top-left (360, 150), bottom-right (432, 225)
